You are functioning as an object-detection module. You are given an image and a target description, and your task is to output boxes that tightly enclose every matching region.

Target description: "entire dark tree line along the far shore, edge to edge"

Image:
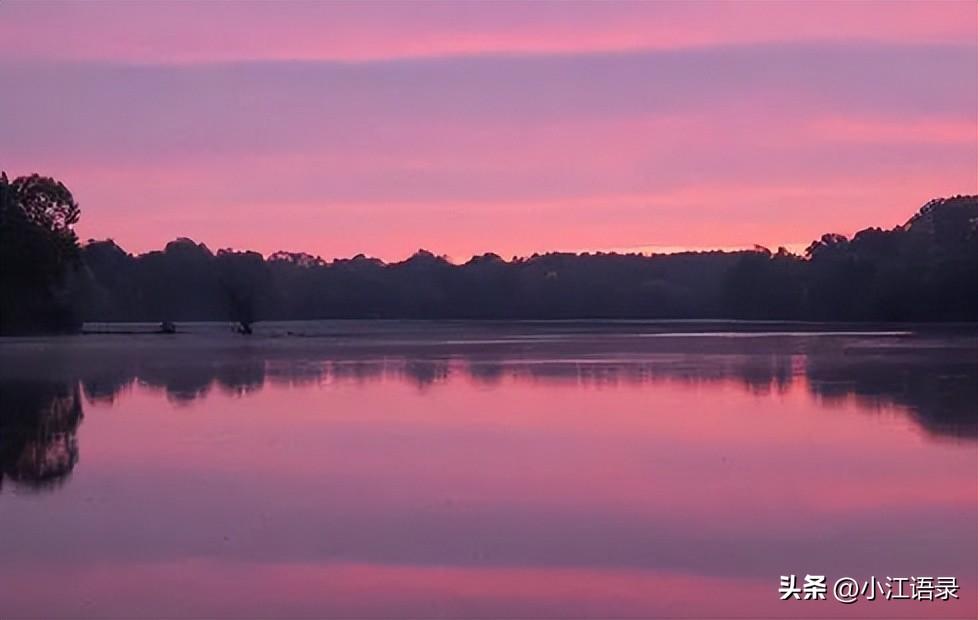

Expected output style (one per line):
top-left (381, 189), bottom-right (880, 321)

top-left (0, 170), bottom-right (978, 333)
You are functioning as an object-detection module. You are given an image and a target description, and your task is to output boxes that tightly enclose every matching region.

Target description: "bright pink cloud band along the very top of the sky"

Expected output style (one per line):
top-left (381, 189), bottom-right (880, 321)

top-left (0, 2), bottom-right (976, 63)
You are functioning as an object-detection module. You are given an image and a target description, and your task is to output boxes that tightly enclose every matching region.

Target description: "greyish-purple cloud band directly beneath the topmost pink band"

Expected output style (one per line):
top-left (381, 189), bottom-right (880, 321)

top-left (0, 44), bottom-right (978, 159)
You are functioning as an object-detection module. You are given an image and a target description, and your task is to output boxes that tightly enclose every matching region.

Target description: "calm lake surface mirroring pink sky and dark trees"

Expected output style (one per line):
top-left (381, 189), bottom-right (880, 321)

top-left (0, 323), bottom-right (978, 618)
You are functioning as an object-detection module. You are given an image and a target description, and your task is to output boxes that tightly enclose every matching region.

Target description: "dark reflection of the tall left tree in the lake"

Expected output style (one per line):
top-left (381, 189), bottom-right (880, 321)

top-left (0, 381), bottom-right (83, 489)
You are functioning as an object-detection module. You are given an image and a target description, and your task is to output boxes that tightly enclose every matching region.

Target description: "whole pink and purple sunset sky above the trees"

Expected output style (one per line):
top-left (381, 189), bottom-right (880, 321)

top-left (0, 0), bottom-right (978, 261)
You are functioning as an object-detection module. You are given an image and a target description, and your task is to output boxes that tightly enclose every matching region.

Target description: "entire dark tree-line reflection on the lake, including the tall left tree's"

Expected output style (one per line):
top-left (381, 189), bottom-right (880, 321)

top-left (0, 344), bottom-right (978, 489)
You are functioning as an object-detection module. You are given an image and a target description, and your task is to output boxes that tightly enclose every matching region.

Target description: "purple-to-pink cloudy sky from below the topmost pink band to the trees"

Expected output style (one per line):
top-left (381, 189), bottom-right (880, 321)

top-left (0, 24), bottom-right (978, 259)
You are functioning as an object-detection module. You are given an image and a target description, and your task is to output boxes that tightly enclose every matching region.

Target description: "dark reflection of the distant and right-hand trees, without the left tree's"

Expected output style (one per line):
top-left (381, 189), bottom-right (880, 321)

top-left (63, 348), bottom-right (978, 440)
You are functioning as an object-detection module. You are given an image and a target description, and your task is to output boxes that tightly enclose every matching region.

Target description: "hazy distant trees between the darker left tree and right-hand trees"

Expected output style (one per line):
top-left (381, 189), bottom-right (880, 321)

top-left (83, 240), bottom-right (740, 325)
